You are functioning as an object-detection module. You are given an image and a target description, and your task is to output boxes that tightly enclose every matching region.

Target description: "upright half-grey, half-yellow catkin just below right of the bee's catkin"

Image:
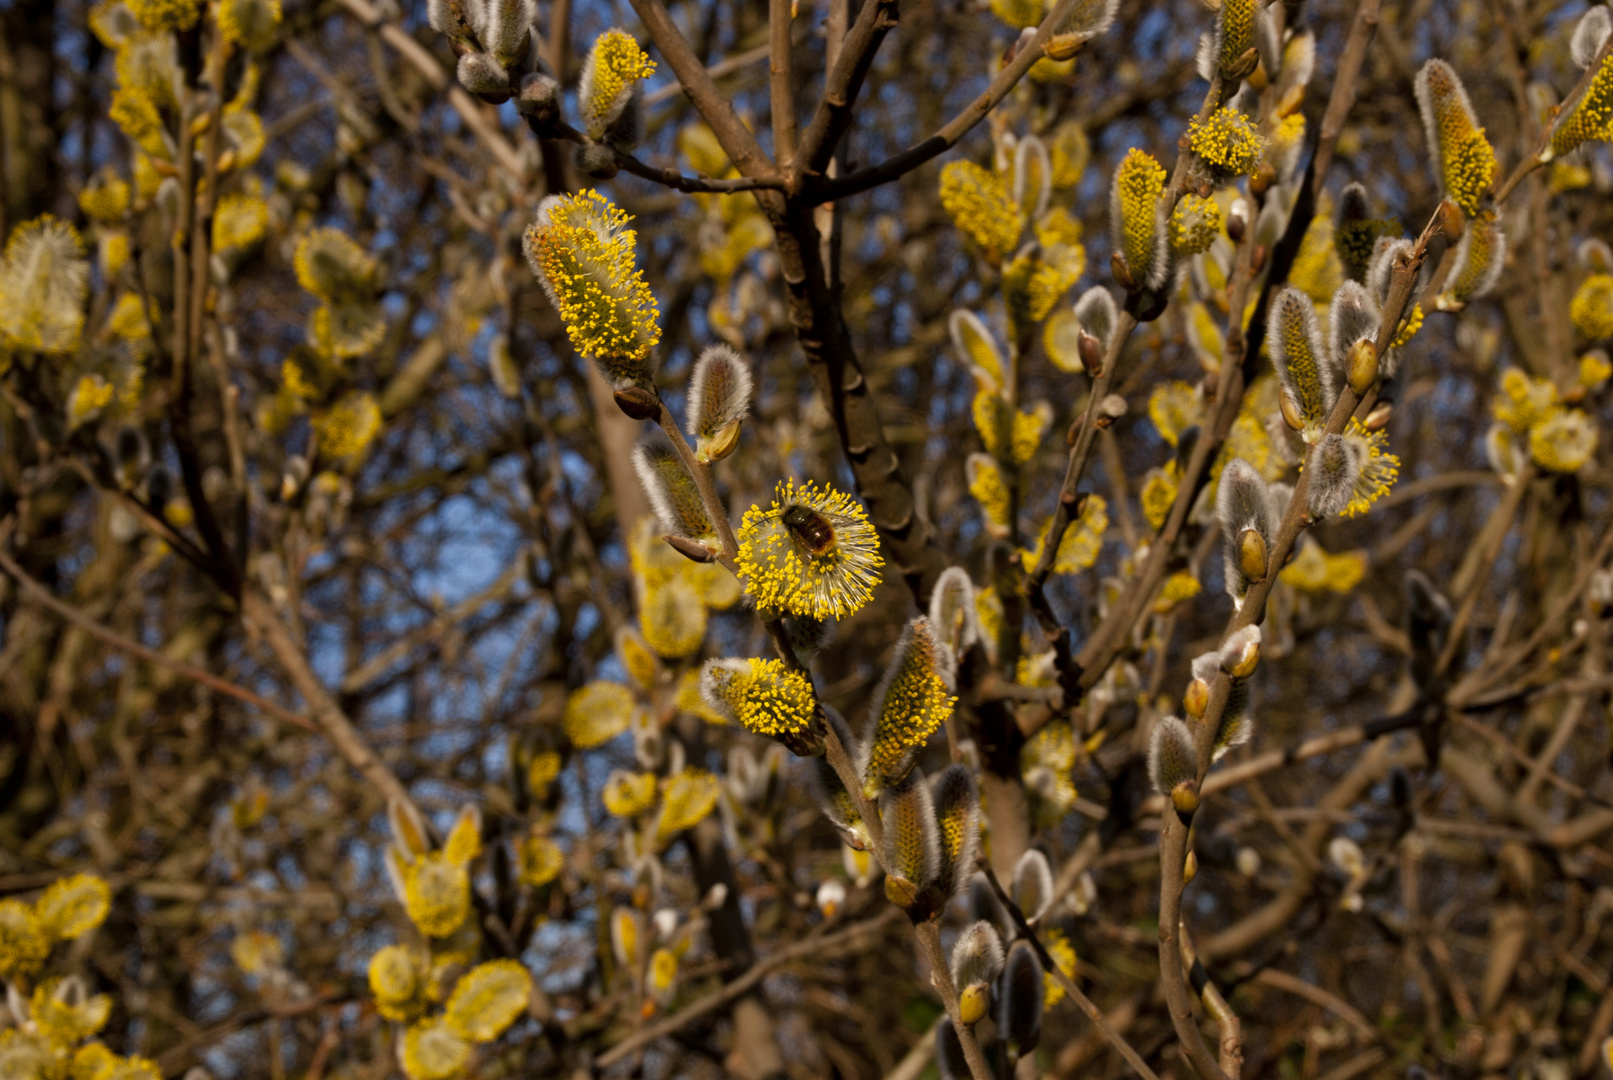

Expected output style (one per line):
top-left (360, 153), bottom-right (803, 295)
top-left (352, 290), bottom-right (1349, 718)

top-left (863, 616), bottom-right (958, 796)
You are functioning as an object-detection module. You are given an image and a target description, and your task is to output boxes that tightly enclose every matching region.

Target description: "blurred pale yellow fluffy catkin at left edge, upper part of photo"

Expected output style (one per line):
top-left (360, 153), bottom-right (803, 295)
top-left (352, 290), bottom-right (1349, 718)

top-left (0, 214), bottom-right (90, 353)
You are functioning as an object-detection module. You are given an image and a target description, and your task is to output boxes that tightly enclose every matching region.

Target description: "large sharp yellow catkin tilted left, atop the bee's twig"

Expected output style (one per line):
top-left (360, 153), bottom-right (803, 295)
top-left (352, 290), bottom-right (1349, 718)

top-left (524, 190), bottom-right (661, 390)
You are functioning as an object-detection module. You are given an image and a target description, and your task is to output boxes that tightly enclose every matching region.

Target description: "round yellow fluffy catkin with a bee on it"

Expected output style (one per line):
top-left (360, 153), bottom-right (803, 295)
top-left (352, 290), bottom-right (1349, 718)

top-left (737, 480), bottom-right (884, 619)
